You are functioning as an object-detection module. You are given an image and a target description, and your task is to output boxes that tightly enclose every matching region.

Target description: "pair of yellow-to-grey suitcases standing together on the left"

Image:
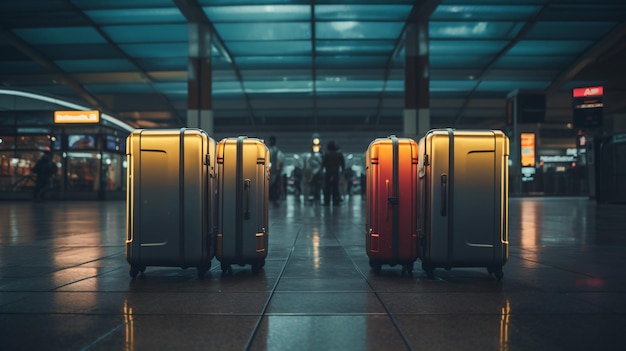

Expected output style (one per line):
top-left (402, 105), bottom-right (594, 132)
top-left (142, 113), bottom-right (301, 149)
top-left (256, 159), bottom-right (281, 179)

top-left (126, 128), bottom-right (269, 278)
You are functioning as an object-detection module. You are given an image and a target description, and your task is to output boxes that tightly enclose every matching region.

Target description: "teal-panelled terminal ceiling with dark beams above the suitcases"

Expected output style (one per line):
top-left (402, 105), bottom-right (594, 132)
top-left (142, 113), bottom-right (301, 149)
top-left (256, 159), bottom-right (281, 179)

top-left (0, 0), bottom-right (626, 153)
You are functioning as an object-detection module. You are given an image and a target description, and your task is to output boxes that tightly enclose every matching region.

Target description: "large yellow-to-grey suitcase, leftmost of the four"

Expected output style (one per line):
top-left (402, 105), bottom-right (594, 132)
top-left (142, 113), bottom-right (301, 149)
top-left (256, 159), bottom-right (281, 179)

top-left (126, 128), bottom-right (215, 278)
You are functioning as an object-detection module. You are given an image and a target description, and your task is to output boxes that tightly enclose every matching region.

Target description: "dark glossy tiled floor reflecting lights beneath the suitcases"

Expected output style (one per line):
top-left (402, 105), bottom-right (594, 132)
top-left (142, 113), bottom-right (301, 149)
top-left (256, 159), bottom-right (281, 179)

top-left (0, 196), bottom-right (626, 351)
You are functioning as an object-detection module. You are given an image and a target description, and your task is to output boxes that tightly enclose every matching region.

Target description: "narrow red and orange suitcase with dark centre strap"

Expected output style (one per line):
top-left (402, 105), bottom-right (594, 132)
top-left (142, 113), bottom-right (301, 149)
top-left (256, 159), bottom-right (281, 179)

top-left (365, 136), bottom-right (419, 274)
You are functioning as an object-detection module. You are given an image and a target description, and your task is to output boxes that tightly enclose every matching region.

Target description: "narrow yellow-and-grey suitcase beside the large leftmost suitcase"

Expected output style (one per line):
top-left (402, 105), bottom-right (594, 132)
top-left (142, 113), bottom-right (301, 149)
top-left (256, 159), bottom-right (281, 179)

top-left (215, 136), bottom-right (270, 274)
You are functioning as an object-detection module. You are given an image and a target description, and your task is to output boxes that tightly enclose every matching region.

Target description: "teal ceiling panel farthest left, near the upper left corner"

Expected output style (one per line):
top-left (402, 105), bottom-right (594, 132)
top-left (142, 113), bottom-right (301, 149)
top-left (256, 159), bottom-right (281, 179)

top-left (13, 27), bottom-right (106, 45)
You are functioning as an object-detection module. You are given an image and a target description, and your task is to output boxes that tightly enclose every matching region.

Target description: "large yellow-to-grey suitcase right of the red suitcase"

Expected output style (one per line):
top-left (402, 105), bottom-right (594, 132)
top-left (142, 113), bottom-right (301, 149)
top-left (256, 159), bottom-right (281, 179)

top-left (419, 129), bottom-right (509, 280)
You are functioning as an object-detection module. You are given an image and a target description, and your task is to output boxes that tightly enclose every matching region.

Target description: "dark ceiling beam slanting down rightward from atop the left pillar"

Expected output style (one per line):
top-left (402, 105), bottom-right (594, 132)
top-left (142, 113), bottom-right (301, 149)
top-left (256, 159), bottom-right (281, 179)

top-left (173, 0), bottom-right (256, 128)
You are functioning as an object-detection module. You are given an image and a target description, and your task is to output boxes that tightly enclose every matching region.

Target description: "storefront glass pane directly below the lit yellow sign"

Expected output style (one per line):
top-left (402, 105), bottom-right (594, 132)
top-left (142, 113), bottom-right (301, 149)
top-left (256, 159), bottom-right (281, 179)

top-left (67, 152), bottom-right (100, 191)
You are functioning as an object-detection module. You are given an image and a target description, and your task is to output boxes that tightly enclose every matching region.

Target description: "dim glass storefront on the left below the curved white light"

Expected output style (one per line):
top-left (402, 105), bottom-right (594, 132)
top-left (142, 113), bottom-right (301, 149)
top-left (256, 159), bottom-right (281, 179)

top-left (0, 111), bottom-right (129, 200)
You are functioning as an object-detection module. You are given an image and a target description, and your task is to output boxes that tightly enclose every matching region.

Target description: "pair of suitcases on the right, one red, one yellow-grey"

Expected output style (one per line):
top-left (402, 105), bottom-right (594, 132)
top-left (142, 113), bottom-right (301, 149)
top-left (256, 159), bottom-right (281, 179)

top-left (365, 129), bottom-right (509, 280)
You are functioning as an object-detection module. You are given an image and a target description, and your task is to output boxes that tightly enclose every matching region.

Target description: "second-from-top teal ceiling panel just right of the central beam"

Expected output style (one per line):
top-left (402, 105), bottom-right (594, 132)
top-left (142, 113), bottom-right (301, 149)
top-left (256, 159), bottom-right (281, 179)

top-left (315, 21), bottom-right (404, 40)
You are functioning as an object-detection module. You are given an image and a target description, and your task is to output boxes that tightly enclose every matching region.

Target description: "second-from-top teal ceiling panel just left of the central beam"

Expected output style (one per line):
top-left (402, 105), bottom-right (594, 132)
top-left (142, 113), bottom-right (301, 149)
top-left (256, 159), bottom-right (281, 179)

top-left (215, 22), bottom-right (311, 42)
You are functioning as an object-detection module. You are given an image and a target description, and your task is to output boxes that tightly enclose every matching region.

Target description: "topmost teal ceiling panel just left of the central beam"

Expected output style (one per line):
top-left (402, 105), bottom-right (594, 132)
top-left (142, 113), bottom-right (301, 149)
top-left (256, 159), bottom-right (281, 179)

top-left (203, 5), bottom-right (311, 23)
